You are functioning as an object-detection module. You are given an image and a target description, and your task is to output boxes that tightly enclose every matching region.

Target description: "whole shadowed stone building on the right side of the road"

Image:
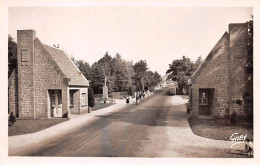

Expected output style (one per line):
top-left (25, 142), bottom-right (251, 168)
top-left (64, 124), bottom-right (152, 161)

top-left (189, 23), bottom-right (253, 118)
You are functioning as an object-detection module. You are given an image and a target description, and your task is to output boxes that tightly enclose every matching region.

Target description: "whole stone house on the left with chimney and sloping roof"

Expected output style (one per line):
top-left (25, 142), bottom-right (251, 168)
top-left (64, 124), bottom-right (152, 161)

top-left (8, 30), bottom-right (89, 119)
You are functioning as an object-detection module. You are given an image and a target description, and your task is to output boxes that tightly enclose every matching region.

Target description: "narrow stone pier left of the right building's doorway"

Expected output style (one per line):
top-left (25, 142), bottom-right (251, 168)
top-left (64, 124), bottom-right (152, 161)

top-left (191, 84), bottom-right (199, 117)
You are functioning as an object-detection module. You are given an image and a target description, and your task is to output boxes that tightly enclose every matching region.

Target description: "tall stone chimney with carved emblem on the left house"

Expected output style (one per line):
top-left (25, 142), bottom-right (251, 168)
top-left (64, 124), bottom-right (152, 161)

top-left (17, 30), bottom-right (36, 119)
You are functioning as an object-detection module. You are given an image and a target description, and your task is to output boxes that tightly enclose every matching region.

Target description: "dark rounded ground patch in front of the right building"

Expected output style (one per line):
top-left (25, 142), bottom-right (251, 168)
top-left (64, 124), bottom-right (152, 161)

top-left (189, 118), bottom-right (253, 141)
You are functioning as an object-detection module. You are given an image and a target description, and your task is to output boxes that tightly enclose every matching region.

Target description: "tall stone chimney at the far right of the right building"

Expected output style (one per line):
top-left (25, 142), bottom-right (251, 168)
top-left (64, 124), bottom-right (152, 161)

top-left (229, 23), bottom-right (248, 116)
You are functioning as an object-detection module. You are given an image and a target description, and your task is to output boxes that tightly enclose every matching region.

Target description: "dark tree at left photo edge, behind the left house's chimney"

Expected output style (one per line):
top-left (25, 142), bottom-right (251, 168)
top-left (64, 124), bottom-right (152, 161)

top-left (8, 35), bottom-right (17, 77)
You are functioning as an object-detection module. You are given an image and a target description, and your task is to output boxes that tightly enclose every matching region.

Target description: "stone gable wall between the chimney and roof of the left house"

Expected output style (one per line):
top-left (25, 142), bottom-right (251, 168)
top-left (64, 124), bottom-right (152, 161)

top-left (34, 38), bottom-right (65, 118)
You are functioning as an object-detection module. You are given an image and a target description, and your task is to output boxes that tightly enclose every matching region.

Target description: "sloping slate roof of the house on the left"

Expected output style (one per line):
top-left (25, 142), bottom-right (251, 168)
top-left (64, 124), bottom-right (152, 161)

top-left (43, 44), bottom-right (89, 86)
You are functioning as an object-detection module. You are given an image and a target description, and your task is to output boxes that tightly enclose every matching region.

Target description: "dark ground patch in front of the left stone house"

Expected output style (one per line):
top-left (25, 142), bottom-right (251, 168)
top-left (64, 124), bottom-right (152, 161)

top-left (8, 118), bottom-right (68, 136)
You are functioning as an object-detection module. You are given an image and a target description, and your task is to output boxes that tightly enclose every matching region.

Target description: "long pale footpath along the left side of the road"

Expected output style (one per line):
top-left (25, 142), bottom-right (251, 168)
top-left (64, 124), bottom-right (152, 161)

top-left (8, 91), bottom-right (156, 156)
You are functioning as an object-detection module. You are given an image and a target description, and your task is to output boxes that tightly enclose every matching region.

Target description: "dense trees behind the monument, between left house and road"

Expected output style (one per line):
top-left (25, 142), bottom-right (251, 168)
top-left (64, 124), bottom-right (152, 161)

top-left (72, 52), bottom-right (161, 95)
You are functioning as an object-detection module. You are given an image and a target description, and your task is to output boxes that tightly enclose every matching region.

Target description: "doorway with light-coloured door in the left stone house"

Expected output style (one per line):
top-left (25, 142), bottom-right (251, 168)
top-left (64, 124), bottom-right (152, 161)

top-left (49, 90), bottom-right (62, 117)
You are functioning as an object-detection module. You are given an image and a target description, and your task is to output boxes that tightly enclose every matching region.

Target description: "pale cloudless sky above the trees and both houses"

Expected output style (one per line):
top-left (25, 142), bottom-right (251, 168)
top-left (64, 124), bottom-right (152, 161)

top-left (8, 6), bottom-right (253, 75)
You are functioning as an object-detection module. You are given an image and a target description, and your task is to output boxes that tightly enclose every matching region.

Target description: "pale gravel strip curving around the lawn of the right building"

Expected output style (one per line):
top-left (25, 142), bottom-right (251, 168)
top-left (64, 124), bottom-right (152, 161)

top-left (166, 96), bottom-right (253, 158)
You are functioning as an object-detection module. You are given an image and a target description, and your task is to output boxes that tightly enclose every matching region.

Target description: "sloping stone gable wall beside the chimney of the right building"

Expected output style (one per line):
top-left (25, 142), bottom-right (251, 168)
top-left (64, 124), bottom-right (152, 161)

top-left (192, 32), bottom-right (229, 117)
